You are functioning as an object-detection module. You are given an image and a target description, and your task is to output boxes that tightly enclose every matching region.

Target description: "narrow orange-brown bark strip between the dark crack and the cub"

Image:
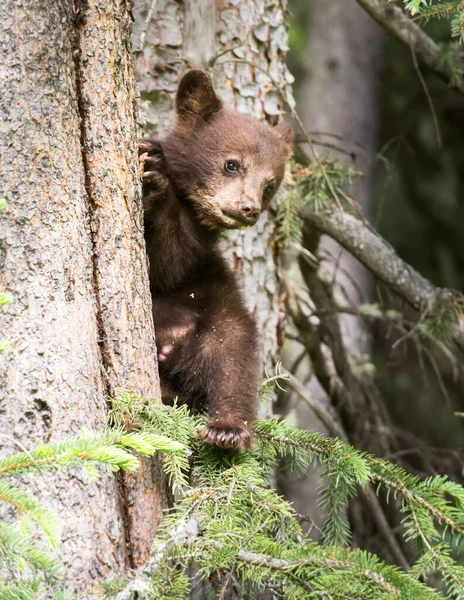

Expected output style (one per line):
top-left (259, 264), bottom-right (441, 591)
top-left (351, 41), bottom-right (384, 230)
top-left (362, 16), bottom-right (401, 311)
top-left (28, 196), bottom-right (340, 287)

top-left (78, 0), bottom-right (164, 566)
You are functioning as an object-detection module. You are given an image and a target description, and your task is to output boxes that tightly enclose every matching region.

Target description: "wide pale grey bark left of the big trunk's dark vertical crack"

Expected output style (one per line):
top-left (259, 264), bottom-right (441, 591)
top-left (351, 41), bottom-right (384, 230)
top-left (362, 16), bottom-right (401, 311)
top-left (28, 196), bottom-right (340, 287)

top-left (0, 0), bottom-right (126, 590)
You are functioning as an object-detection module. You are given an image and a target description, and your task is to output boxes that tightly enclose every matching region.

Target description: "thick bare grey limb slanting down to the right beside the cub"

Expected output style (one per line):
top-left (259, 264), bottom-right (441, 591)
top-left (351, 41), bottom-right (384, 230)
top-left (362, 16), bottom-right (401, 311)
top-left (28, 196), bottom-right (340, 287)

top-left (302, 203), bottom-right (464, 351)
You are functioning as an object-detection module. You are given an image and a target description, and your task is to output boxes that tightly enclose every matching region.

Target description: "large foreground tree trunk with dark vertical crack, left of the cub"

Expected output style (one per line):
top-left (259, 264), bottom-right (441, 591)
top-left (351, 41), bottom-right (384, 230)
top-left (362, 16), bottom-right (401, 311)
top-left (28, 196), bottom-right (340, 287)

top-left (0, 0), bottom-right (163, 598)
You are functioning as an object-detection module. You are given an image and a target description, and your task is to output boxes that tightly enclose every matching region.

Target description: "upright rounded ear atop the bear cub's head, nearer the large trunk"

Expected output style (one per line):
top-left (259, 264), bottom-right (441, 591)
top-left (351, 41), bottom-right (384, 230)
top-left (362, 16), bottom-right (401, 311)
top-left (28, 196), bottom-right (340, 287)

top-left (176, 69), bottom-right (222, 126)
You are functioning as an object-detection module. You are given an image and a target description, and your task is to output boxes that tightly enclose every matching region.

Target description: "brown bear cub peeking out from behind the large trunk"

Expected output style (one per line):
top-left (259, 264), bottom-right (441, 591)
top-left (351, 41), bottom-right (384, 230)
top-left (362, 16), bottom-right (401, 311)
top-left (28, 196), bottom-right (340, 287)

top-left (139, 70), bottom-right (293, 450)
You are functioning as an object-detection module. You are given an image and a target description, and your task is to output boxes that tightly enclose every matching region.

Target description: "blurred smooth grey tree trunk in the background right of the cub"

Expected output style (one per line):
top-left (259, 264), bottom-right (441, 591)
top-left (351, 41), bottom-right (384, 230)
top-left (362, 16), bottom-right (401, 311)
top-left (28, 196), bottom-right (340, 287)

top-left (283, 0), bottom-right (384, 537)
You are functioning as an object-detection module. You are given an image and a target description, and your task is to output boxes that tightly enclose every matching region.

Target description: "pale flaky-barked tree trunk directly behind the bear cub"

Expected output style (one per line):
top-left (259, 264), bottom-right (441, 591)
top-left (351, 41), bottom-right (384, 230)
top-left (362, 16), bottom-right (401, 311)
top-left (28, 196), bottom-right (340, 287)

top-left (134, 0), bottom-right (291, 414)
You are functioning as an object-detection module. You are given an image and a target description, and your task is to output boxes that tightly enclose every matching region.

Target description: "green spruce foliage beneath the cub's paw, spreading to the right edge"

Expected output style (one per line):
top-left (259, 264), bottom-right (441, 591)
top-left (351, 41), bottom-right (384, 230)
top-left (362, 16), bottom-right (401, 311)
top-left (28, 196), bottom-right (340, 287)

top-left (107, 392), bottom-right (464, 600)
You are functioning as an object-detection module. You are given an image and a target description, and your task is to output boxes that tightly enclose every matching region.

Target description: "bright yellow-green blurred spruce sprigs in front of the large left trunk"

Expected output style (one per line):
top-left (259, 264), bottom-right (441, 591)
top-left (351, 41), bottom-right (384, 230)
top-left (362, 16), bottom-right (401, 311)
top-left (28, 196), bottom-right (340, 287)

top-left (0, 429), bottom-right (183, 600)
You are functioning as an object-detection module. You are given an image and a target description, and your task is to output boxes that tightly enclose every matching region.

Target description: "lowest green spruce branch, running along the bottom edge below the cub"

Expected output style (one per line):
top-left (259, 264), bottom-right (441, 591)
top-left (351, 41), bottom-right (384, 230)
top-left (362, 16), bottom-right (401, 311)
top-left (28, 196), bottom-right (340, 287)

top-left (116, 507), bottom-right (439, 600)
